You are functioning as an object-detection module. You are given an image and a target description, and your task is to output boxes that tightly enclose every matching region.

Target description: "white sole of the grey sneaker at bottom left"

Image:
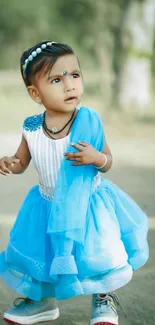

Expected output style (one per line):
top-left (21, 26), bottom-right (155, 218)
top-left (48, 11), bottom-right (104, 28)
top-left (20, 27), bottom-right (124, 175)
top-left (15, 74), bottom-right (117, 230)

top-left (3, 308), bottom-right (60, 325)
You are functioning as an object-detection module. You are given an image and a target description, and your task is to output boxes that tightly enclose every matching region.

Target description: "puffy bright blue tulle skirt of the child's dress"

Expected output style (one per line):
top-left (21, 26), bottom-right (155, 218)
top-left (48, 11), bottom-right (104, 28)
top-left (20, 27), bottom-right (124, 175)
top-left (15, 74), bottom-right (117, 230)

top-left (0, 179), bottom-right (149, 300)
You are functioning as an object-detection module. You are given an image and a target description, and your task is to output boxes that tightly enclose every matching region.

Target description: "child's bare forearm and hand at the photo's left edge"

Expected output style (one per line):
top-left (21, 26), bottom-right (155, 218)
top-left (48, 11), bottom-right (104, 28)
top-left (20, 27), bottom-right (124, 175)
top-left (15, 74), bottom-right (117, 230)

top-left (0, 136), bottom-right (31, 176)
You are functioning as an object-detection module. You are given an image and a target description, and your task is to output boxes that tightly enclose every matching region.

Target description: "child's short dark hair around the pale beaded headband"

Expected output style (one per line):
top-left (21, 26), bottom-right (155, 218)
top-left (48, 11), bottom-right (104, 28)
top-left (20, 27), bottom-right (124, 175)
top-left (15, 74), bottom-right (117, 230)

top-left (20, 41), bottom-right (74, 87)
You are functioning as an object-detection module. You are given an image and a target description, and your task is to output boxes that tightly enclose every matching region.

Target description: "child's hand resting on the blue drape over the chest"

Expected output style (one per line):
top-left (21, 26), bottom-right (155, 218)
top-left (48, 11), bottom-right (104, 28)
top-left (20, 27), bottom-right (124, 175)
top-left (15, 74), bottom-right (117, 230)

top-left (64, 141), bottom-right (99, 166)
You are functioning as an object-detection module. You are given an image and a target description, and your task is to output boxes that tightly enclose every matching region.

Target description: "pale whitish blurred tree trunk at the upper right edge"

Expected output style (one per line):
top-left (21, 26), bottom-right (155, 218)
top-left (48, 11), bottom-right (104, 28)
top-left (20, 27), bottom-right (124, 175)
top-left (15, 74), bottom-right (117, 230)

top-left (118, 0), bottom-right (155, 113)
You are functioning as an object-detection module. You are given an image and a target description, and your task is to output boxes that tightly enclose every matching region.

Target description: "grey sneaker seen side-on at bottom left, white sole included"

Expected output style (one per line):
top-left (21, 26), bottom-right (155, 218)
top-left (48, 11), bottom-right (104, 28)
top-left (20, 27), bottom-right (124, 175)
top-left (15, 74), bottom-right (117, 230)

top-left (3, 298), bottom-right (59, 324)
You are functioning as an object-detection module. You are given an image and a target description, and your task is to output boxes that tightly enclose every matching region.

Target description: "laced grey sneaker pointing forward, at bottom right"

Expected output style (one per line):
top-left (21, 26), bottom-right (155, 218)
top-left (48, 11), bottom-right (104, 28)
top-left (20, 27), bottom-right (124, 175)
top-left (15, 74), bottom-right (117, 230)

top-left (90, 293), bottom-right (119, 325)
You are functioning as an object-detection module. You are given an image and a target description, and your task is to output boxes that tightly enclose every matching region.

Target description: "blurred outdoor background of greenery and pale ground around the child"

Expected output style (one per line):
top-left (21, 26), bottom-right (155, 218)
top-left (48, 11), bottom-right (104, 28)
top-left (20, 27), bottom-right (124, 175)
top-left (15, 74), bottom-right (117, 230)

top-left (0, 0), bottom-right (155, 325)
